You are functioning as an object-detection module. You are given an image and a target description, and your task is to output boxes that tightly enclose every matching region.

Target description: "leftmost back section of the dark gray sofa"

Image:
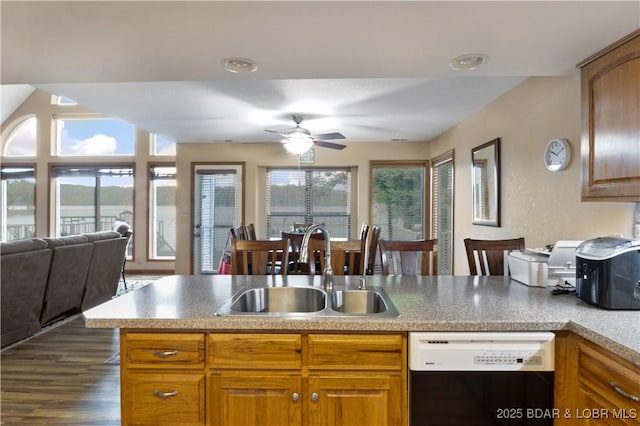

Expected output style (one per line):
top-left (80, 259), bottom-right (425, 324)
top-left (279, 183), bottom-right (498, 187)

top-left (0, 238), bottom-right (51, 347)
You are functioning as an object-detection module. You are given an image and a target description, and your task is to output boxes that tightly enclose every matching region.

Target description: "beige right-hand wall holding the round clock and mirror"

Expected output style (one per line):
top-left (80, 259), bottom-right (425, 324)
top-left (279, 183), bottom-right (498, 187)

top-left (430, 72), bottom-right (633, 275)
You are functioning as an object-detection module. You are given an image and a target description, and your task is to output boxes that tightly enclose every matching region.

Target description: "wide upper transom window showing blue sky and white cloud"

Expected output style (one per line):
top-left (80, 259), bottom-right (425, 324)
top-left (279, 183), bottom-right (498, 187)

top-left (55, 118), bottom-right (136, 157)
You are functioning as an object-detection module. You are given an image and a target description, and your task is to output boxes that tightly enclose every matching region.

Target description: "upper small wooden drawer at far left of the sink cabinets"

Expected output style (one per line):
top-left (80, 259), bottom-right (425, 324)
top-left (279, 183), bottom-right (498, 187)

top-left (124, 333), bottom-right (204, 368)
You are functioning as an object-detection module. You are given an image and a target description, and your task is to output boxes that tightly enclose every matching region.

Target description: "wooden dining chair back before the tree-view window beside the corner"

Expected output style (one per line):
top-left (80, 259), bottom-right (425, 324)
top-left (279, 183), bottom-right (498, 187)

top-left (378, 239), bottom-right (438, 275)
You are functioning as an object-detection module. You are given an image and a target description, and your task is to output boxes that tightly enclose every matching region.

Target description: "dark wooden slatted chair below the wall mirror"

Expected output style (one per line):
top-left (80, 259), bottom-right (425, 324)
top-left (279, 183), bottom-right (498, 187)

top-left (464, 237), bottom-right (525, 275)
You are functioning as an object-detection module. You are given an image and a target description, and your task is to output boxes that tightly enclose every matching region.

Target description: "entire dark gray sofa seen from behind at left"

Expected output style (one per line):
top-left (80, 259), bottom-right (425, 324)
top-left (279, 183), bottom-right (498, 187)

top-left (0, 231), bottom-right (129, 347)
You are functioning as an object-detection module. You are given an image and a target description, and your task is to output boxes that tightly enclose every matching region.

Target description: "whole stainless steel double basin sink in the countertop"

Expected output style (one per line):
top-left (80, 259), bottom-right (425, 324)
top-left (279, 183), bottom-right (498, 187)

top-left (216, 286), bottom-right (400, 317)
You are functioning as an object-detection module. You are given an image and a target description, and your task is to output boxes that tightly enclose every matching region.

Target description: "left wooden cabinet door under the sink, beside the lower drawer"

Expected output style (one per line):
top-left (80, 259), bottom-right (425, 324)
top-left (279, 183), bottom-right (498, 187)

top-left (209, 372), bottom-right (302, 426)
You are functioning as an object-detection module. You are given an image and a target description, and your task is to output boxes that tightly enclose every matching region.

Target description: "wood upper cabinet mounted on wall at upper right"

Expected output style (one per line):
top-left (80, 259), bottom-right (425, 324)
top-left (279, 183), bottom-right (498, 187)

top-left (578, 30), bottom-right (640, 201)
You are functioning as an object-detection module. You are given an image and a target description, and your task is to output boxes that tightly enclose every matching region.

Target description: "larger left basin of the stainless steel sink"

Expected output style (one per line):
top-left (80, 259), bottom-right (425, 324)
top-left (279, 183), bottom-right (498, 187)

top-left (218, 287), bottom-right (327, 314)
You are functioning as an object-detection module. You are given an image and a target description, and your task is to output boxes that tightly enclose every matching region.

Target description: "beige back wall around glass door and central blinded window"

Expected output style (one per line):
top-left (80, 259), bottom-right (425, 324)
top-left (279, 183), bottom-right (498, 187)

top-left (176, 142), bottom-right (429, 274)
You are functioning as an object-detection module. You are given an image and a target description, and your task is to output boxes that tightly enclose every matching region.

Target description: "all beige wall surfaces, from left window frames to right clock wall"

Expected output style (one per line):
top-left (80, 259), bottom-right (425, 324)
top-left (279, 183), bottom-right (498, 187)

top-left (2, 78), bottom-right (633, 275)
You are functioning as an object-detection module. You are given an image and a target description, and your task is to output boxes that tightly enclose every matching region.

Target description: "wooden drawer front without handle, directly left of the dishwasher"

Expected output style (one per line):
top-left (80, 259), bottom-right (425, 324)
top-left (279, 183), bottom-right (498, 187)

top-left (308, 334), bottom-right (403, 370)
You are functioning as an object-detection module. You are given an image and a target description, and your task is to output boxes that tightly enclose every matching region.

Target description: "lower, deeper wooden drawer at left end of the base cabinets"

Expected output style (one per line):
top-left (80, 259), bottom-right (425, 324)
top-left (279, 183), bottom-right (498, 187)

top-left (123, 373), bottom-right (205, 426)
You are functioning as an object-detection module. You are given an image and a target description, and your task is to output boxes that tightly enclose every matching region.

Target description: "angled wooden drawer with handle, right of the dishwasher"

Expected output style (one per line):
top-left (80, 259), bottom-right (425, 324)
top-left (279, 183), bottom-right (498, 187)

top-left (578, 340), bottom-right (640, 415)
